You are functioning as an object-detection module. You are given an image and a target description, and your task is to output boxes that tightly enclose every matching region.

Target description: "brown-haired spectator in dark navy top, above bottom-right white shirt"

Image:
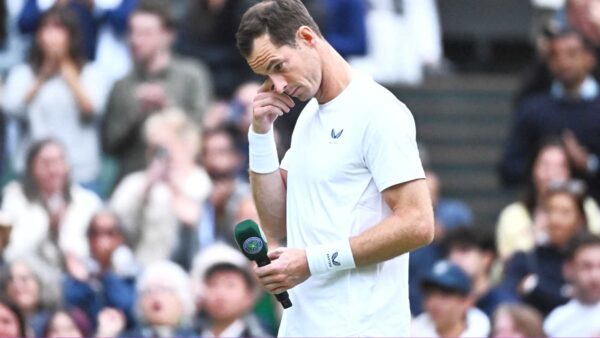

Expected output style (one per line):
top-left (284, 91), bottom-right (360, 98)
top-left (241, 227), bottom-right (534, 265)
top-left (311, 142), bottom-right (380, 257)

top-left (503, 181), bottom-right (586, 315)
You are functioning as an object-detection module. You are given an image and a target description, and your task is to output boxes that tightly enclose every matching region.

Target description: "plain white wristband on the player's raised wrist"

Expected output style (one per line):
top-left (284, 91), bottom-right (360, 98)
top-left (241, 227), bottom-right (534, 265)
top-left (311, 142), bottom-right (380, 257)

top-left (248, 126), bottom-right (279, 174)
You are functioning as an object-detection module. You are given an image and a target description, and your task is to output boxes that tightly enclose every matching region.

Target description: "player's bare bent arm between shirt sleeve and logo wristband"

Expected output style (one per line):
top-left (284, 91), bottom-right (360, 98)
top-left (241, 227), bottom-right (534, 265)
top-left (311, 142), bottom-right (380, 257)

top-left (350, 179), bottom-right (434, 266)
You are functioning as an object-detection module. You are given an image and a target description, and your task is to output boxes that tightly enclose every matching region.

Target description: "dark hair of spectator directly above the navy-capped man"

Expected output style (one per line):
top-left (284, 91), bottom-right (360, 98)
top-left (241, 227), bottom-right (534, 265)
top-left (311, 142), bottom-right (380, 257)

top-left (443, 226), bottom-right (496, 255)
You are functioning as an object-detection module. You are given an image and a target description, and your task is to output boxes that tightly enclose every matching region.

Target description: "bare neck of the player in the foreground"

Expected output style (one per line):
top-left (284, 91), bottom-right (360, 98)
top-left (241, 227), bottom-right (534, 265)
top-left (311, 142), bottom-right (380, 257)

top-left (315, 44), bottom-right (352, 104)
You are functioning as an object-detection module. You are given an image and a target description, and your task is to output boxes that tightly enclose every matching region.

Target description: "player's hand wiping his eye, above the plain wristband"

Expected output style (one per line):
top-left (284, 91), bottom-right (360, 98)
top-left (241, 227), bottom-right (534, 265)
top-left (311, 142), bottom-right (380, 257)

top-left (252, 79), bottom-right (295, 134)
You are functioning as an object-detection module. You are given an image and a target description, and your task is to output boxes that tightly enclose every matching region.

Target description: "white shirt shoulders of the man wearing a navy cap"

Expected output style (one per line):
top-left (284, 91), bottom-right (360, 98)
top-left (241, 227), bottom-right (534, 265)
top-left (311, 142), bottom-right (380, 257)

top-left (410, 308), bottom-right (490, 337)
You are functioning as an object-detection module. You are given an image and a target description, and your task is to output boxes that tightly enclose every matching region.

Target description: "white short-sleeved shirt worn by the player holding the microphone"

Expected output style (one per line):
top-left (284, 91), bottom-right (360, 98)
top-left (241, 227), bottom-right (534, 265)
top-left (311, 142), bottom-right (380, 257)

top-left (279, 73), bottom-right (425, 337)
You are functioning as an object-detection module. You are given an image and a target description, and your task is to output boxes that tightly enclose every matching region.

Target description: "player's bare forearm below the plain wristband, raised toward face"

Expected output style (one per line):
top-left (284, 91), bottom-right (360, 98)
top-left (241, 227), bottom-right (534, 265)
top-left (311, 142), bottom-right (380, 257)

top-left (250, 169), bottom-right (287, 249)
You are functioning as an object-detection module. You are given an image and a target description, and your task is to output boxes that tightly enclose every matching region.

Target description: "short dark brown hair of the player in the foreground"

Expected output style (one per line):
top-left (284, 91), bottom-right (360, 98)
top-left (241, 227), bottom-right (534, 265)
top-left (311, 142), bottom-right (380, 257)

top-left (236, 0), bottom-right (322, 57)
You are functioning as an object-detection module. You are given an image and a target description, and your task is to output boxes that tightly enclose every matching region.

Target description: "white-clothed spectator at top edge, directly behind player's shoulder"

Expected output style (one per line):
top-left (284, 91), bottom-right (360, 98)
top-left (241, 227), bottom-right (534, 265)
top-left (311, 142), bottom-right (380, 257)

top-left (350, 0), bottom-right (442, 85)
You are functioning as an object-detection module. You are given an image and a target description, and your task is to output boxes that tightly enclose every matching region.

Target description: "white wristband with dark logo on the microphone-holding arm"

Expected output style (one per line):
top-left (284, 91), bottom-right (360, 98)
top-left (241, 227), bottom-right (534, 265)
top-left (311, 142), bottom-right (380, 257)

top-left (306, 239), bottom-right (356, 275)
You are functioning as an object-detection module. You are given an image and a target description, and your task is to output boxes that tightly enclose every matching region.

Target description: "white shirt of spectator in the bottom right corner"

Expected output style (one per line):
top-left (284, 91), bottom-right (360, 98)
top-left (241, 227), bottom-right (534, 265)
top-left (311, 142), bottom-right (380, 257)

top-left (544, 299), bottom-right (600, 337)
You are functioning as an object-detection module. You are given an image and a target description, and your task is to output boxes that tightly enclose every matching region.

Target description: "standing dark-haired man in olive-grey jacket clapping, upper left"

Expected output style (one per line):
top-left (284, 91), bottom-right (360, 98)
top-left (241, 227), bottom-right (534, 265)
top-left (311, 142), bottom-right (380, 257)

top-left (102, 0), bottom-right (212, 185)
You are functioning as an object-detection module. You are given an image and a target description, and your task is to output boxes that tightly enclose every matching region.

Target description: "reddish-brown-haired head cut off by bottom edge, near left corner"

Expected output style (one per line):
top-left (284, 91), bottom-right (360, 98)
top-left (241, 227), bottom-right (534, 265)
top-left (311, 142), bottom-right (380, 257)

top-left (44, 308), bottom-right (92, 338)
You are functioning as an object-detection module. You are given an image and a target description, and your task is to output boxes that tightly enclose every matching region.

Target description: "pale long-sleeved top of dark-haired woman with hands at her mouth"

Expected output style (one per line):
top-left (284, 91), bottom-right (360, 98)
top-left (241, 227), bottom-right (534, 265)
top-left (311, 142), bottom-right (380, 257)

top-left (3, 64), bottom-right (108, 183)
